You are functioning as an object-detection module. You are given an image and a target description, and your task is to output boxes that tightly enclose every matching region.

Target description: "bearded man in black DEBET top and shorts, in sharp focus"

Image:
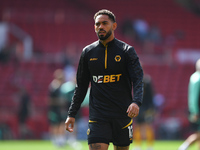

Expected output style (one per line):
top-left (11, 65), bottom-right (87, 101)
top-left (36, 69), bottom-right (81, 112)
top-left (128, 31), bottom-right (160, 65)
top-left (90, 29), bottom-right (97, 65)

top-left (65, 9), bottom-right (143, 150)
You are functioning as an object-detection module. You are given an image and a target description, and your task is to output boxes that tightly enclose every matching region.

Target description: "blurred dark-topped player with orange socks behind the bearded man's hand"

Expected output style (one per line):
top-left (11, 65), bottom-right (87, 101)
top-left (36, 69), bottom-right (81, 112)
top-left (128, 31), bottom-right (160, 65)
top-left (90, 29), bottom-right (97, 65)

top-left (133, 74), bottom-right (155, 150)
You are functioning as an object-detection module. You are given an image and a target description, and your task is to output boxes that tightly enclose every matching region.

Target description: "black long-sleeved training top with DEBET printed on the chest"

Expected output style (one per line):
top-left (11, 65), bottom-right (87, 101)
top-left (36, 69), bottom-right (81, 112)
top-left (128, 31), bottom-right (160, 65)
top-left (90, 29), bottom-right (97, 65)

top-left (68, 39), bottom-right (143, 119)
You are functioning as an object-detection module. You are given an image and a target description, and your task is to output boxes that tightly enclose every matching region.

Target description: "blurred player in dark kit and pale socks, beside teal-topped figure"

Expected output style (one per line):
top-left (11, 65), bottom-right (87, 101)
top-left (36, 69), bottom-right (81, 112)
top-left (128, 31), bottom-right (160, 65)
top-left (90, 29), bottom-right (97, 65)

top-left (48, 69), bottom-right (67, 146)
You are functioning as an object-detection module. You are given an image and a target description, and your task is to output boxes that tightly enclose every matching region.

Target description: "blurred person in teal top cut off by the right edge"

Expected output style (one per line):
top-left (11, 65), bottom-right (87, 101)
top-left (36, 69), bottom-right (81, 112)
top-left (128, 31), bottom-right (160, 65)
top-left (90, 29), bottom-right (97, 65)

top-left (178, 59), bottom-right (200, 150)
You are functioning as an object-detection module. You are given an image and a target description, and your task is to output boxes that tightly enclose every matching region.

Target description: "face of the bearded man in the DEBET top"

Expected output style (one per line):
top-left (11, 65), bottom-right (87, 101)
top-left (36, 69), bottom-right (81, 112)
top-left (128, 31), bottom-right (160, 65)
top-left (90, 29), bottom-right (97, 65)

top-left (94, 15), bottom-right (113, 40)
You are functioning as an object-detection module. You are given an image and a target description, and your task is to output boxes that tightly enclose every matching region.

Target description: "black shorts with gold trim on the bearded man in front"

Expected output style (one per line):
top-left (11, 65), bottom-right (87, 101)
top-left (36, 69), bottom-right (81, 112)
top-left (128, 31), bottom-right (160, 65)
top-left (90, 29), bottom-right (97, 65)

top-left (87, 118), bottom-right (133, 146)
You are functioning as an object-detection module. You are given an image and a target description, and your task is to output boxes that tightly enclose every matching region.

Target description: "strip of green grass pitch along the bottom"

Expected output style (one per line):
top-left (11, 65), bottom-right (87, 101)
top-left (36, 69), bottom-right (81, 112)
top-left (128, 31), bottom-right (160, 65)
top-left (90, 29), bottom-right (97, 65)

top-left (0, 140), bottom-right (197, 150)
